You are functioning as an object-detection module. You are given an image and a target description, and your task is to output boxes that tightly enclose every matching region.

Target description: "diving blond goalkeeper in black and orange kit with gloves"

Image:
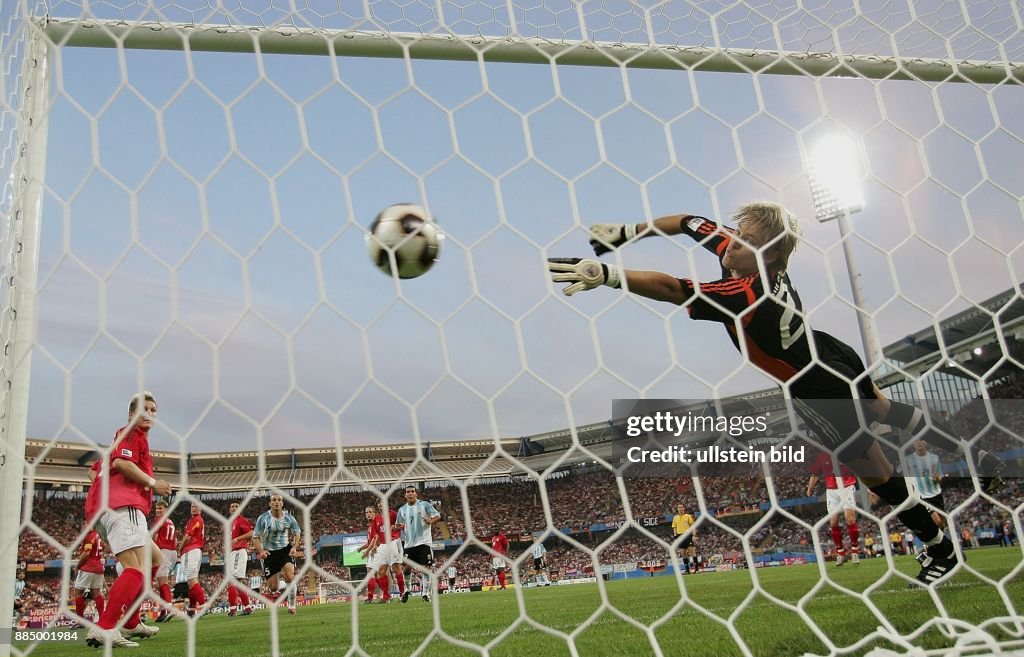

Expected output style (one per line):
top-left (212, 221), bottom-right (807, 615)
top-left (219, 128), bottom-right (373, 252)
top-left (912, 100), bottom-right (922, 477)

top-left (548, 203), bottom-right (1004, 585)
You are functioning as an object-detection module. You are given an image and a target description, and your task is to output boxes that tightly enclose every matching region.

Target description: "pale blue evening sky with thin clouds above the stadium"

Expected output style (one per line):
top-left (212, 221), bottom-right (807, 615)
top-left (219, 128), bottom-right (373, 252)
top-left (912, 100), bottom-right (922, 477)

top-left (9, 3), bottom-right (1024, 451)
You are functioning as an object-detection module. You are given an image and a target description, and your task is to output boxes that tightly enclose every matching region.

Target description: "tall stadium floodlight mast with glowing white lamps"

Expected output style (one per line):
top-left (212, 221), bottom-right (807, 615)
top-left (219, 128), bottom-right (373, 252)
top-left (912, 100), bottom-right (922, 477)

top-left (807, 135), bottom-right (883, 367)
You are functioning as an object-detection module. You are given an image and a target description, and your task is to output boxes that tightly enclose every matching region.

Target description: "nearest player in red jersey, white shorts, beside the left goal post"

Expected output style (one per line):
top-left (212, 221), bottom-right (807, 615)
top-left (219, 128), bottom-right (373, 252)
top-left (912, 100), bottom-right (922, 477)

top-left (85, 392), bottom-right (171, 648)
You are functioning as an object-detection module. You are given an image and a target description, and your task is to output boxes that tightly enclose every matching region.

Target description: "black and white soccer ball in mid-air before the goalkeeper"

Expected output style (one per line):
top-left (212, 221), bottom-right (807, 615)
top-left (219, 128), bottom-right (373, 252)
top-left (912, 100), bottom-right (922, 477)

top-left (367, 203), bottom-right (441, 278)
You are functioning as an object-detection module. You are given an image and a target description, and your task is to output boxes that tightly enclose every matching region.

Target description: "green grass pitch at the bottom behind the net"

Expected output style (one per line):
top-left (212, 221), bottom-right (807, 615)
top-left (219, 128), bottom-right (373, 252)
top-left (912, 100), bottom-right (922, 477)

top-left (20, 548), bottom-right (1024, 657)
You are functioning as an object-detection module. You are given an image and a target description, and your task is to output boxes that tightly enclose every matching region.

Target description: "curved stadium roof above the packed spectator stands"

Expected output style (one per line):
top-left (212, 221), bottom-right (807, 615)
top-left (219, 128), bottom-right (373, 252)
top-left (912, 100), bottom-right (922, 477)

top-left (26, 290), bottom-right (1024, 492)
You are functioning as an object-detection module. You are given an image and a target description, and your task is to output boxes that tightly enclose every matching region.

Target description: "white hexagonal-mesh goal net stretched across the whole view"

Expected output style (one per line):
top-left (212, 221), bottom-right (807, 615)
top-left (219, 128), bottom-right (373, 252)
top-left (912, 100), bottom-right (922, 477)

top-left (0, 0), bottom-right (1024, 655)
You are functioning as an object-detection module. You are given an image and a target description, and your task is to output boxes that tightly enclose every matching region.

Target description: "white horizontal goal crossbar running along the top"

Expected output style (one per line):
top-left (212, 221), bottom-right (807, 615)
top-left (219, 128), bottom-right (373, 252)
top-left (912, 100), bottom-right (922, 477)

top-left (39, 18), bottom-right (1024, 84)
